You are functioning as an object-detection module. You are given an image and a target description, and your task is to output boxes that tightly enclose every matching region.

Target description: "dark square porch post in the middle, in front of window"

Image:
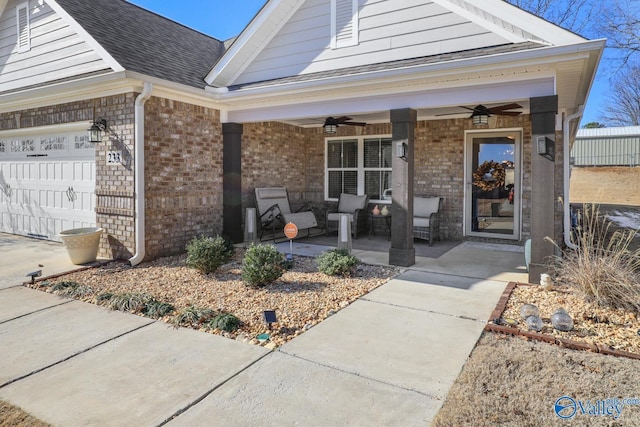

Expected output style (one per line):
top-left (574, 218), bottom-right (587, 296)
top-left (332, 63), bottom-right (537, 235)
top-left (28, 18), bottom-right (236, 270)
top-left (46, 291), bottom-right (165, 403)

top-left (389, 108), bottom-right (418, 267)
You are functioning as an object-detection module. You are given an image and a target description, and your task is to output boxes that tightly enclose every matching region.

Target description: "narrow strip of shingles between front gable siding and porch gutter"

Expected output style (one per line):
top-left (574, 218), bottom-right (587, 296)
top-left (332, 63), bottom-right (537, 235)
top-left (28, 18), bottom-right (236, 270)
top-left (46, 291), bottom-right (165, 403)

top-left (229, 42), bottom-right (546, 90)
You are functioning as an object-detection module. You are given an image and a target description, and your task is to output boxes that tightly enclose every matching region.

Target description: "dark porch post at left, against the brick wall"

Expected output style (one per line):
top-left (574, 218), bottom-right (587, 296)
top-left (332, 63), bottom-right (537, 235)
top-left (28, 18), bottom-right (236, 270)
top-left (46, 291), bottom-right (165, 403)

top-left (222, 123), bottom-right (244, 243)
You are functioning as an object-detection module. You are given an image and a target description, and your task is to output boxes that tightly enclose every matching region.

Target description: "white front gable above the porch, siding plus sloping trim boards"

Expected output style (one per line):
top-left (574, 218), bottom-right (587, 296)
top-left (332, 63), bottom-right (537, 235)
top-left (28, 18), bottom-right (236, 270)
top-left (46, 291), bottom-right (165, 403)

top-left (206, 0), bottom-right (586, 87)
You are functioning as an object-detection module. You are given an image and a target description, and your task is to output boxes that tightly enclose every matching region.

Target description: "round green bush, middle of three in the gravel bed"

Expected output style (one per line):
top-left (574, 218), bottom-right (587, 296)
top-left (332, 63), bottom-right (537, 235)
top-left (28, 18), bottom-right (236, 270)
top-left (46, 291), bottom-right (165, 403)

top-left (242, 244), bottom-right (284, 286)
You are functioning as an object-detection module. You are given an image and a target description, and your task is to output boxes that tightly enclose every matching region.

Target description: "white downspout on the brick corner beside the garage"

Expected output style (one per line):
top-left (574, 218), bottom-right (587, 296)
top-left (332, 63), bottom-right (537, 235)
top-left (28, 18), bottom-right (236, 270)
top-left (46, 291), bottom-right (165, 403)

top-left (129, 82), bottom-right (153, 266)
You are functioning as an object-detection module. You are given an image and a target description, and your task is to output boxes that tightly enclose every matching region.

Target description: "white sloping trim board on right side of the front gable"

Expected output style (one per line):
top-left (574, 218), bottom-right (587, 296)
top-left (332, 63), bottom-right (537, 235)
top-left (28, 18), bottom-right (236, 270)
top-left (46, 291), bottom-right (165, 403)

top-left (452, 0), bottom-right (587, 46)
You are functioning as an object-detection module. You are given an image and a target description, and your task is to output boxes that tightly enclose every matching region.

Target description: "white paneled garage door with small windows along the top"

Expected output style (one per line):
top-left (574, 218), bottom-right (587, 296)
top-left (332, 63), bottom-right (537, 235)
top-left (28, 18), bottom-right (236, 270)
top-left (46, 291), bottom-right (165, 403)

top-left (0, 123), bottom-right (96, 241)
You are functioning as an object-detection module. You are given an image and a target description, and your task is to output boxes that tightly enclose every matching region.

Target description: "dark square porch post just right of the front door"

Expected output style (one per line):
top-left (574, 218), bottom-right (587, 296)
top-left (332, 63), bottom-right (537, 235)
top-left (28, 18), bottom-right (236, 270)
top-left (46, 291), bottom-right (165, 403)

top-left (529, 95), bottom-right (558, 283)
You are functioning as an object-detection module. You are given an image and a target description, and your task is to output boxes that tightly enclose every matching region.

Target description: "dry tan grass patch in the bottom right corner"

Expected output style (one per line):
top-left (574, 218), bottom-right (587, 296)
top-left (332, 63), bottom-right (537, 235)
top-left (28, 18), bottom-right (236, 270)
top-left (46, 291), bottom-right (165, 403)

top-left (432, 332), bottom-right (640, 427)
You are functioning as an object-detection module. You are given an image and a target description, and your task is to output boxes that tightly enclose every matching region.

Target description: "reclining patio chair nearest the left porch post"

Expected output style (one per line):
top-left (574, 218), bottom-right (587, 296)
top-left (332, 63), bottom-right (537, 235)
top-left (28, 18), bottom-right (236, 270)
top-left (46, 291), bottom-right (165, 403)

top-left (255, 187), bottom-right (318, 239)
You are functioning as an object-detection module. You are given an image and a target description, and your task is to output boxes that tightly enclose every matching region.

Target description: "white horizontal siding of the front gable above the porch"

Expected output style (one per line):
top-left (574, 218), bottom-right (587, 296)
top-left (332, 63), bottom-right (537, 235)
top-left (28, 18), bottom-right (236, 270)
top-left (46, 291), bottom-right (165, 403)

top-left (235, 0), bottom-right (508, 83)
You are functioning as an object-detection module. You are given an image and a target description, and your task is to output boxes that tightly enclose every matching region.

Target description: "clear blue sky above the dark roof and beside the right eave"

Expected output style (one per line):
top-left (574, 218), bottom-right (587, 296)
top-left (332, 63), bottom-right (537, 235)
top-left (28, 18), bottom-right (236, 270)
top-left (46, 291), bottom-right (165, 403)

top-left (128, 0), bottom-right (608, 126)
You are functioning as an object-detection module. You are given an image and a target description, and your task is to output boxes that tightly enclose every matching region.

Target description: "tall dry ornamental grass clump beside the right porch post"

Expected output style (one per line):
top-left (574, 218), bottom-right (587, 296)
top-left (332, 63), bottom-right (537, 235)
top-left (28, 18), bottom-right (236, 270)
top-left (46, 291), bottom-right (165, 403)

top-left (551, 205), bottom-right (640, 313)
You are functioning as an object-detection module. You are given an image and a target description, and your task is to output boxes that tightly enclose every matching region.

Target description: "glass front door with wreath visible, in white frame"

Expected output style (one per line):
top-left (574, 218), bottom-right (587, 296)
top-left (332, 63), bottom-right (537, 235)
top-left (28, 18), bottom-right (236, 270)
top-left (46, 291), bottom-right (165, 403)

top-left (465, 130), bottom-right (522, 240)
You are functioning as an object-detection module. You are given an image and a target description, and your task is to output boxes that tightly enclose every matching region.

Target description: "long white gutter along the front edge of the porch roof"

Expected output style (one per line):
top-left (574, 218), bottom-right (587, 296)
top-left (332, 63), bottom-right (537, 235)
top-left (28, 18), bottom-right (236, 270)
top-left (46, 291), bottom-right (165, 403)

top-left (210, 40), bottom-right (604, 102)
